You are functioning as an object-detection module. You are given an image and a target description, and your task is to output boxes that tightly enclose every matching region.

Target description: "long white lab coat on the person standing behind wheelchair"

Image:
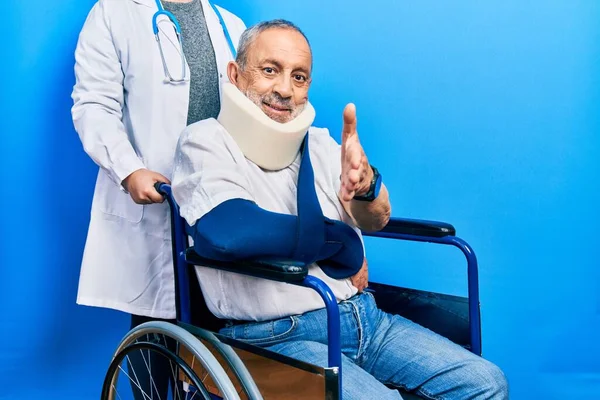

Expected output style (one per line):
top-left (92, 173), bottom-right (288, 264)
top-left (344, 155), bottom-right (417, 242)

top-left (72, 0), bottom-right (245, 318)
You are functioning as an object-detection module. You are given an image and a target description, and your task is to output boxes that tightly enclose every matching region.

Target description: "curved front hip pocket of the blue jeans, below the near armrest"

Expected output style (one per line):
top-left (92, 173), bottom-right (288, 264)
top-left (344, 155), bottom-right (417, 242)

top-left (232, 316), bottom-right (298, 346)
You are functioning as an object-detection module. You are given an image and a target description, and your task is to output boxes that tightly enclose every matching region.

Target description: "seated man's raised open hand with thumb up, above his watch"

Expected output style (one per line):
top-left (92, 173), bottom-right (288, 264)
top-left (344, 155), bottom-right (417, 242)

top-left (339, 103), bottom-right (373, 201)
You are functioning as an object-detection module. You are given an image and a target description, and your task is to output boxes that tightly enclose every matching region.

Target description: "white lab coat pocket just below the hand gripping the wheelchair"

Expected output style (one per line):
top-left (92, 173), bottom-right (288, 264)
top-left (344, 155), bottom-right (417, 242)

top-left (94, 171), bottom-right (144, 224)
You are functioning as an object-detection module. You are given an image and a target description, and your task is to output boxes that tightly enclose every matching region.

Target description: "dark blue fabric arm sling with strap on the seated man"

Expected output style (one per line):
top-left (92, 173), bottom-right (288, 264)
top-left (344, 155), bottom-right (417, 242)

top-left (187, 134), bottom-right (364, 279)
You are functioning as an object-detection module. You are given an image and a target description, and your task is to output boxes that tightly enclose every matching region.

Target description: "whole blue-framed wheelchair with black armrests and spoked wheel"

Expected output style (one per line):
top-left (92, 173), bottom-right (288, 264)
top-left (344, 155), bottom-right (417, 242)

top-left (101, 183), bottom-right (482, 400)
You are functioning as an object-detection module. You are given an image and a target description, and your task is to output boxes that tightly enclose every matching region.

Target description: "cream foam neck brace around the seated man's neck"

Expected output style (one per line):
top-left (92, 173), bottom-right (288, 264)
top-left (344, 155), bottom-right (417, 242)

top-left (217, 82), bottom-right (315, 170)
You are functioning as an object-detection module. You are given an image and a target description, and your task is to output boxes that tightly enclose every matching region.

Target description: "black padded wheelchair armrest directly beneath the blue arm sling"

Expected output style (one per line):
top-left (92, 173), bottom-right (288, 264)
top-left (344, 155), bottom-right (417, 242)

top-left (185, 247), bottom-right (308, 282)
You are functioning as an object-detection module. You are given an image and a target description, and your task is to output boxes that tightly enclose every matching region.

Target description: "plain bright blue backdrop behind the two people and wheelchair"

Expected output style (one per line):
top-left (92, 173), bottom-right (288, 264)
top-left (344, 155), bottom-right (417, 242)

top-left (0, 0), bottom-right (600, 399)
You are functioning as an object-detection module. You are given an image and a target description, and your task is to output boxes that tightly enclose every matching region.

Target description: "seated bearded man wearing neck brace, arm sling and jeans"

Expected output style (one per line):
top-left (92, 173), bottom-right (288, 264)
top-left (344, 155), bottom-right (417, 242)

top-left (173, 20), bottom-right (508, 399)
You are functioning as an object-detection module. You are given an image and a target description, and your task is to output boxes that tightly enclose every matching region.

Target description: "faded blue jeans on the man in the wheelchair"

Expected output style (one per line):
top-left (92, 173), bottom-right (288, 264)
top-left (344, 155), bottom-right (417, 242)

top-left (220, 292), bottom-right (508, 400)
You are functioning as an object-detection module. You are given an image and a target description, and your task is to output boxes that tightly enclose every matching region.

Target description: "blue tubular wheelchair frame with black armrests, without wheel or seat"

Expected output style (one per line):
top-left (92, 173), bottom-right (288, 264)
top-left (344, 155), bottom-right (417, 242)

top-left (145, 183), bottom-right (482, 398)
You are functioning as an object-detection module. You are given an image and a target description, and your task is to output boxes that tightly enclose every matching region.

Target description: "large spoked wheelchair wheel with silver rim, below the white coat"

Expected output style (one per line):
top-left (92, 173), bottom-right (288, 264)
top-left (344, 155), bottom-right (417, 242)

top-left (101, 321), bottom-right (240, 400)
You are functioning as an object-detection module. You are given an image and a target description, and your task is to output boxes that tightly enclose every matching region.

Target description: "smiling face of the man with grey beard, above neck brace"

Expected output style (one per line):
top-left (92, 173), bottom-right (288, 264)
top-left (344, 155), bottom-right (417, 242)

top-left (228, 28), bottom-right (312, 123)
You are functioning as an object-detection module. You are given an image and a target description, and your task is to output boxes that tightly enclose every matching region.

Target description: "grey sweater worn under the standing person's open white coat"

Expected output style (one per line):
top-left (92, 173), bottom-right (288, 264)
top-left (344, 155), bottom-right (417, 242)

top-left (163, 0), bottom-right (221, 125)
